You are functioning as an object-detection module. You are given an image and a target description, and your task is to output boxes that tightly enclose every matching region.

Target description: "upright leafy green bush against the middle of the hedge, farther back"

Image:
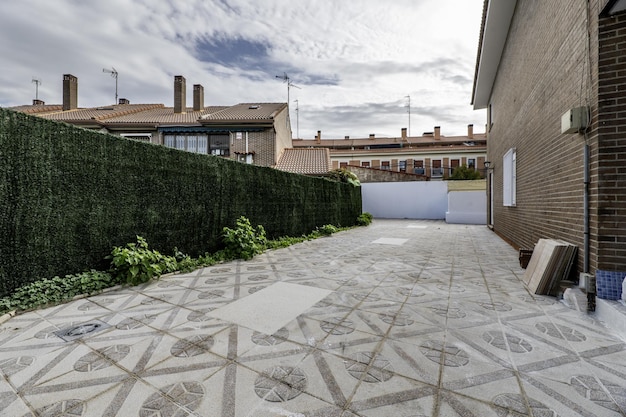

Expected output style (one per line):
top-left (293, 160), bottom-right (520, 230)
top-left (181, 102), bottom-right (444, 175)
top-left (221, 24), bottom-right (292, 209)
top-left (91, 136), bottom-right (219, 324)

top-left (223, 216), bottom-right (267, 260)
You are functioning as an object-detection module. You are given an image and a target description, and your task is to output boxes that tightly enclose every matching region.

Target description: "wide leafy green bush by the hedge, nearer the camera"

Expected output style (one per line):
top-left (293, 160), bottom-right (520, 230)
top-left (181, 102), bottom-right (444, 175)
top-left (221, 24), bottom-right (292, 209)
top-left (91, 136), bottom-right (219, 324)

top-left (110, 236), bottom-right (177, 285)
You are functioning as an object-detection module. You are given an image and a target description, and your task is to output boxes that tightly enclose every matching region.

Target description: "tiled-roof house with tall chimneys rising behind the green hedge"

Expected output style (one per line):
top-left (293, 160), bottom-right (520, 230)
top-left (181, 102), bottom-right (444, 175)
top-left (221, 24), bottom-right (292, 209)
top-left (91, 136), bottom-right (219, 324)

top-left (12, 74), bottom-right (291, 166)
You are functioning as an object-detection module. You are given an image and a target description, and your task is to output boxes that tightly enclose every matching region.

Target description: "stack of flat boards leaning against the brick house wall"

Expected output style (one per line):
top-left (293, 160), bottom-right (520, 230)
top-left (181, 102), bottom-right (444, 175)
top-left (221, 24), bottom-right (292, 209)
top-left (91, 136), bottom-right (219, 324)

top-left (524, 239), bottom-right (578, 295)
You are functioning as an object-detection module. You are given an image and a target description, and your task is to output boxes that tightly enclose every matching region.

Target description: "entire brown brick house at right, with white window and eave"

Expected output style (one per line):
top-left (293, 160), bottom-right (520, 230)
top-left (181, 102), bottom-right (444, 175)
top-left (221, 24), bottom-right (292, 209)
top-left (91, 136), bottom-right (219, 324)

top-left (472, 0), bottom-right (626, 296)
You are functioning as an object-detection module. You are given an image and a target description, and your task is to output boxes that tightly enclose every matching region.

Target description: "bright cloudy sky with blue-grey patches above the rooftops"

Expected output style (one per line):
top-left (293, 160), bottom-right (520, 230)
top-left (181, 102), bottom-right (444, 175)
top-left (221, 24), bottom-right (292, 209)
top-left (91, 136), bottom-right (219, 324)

top-left (0, 0), bottom-right (486, 139)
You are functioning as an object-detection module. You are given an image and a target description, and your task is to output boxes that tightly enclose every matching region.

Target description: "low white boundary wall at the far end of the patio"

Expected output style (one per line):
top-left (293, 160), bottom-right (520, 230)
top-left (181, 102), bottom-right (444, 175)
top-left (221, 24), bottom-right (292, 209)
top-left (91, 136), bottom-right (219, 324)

top-left (361, 181), bottom-right (487, 224)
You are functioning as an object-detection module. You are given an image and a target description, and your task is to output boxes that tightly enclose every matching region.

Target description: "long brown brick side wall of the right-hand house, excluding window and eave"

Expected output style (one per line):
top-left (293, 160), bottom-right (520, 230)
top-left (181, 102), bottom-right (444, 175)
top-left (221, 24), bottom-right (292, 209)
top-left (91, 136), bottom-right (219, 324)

top-left (487, 0), bottom-right (605, 269)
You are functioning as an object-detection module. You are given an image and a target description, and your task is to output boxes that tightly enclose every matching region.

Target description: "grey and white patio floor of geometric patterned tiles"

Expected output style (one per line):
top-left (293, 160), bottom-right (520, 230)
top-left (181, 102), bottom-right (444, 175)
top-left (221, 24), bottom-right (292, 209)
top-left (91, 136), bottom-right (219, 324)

top-left (0, 220), bottom-right (626, 417)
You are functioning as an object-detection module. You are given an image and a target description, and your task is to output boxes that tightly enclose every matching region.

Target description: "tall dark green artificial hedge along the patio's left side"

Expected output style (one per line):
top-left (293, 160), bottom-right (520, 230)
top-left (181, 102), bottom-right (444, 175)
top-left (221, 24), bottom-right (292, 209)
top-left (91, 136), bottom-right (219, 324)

top-left (0, 108), bottom-right (361, 297)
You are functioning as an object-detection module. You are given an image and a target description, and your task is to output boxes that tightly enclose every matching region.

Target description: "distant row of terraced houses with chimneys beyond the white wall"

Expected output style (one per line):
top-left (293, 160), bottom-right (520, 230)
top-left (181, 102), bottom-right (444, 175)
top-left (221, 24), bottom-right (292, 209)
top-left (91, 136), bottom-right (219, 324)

top-left (293, 125), bottom-right (487, 180)
